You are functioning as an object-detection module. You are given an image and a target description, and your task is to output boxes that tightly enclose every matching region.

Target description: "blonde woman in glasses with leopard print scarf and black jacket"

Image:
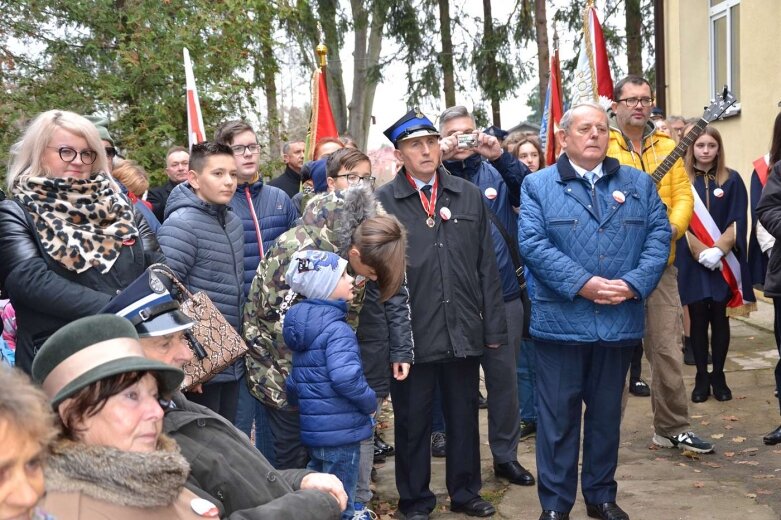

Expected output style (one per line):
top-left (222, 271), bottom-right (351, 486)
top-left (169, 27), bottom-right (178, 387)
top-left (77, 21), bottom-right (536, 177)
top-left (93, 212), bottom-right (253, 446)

top-left (0, 110), bottom-right (164, 373)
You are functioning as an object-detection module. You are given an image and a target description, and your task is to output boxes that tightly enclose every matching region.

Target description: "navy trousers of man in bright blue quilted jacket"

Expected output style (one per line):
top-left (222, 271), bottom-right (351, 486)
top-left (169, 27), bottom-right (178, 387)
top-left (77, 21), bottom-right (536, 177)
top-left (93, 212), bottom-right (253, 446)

top-left (534, 340), bottom-right (639, 512)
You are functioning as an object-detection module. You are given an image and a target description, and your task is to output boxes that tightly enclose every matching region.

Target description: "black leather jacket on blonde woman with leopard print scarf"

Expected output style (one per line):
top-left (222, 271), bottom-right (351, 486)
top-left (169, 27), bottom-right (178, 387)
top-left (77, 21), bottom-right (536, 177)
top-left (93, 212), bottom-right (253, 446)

top-left (0, 199), bottom-right (165, 374)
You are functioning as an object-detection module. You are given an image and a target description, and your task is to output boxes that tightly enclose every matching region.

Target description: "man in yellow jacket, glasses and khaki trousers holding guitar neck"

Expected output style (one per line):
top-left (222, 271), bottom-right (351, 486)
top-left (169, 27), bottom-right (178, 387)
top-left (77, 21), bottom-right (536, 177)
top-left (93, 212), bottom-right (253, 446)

top-left (607, 75), bottom-right (713, 453)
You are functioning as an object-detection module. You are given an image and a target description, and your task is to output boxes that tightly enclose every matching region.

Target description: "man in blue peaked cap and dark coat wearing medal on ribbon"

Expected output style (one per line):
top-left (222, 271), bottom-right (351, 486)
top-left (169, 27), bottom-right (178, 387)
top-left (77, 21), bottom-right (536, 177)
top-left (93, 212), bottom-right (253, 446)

top-left (377, 111), bottom-right (507, 520)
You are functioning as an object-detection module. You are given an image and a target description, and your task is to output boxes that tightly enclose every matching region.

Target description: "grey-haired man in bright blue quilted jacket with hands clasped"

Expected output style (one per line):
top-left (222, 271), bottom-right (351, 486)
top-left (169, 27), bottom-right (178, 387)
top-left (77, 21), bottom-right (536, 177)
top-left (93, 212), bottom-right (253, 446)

top-left (518, 103), bottom-right (670, 520)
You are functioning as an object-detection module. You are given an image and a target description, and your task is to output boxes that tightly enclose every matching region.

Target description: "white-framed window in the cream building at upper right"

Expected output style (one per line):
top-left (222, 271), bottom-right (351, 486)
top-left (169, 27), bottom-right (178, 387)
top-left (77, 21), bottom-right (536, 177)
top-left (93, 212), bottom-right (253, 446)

top-left (709, 0), bottom-right (740, 110)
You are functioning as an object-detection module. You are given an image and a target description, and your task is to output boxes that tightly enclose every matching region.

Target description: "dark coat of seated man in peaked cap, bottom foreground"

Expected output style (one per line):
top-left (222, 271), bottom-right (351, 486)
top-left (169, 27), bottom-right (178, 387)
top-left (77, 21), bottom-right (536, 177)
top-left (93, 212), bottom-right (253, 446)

top-left (163, 393), bottom-right (341, 520)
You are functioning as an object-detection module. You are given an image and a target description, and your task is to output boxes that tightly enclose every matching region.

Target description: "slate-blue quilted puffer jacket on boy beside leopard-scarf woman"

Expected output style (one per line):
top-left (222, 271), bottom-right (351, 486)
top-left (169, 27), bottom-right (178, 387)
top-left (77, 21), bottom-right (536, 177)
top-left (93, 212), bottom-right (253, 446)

top-left (157, 182), bottom-right (244, 383)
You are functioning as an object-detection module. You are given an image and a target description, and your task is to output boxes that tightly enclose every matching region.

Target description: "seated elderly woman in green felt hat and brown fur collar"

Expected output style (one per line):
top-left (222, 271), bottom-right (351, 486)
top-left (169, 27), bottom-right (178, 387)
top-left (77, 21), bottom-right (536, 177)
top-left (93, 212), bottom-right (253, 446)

top-left (33, 314), bottom-right (219, 520)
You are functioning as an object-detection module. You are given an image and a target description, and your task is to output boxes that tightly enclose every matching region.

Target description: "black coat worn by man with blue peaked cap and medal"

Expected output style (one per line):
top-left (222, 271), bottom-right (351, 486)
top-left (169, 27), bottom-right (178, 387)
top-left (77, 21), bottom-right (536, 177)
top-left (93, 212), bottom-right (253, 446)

top-left (376, 168), bottom-right (507, 363)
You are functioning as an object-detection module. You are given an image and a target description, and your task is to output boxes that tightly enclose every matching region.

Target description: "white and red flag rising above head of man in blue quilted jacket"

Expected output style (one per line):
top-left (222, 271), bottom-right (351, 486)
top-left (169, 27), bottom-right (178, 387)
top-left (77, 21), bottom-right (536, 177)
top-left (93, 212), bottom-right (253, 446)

top-left (572, 1), bottom-right (613, 108)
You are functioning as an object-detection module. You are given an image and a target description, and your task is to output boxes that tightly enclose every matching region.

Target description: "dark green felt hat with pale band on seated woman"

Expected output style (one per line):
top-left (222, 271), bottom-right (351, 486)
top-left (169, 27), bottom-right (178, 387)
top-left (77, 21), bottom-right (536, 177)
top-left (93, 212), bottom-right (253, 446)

top-left (32, 314), bottom-right (184, 410)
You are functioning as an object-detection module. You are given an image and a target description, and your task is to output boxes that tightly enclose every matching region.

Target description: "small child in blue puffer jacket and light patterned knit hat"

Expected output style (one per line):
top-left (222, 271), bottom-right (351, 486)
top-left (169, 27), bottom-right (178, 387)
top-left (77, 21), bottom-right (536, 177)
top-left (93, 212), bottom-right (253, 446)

top-left (282, 250), bottom-right (377, 519)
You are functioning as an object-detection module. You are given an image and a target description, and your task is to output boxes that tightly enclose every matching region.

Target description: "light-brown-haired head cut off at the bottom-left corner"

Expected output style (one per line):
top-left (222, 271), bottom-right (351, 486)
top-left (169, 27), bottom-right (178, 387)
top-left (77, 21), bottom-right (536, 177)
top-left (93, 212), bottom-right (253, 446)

top-left (0, 365), bottom-right (55, 520)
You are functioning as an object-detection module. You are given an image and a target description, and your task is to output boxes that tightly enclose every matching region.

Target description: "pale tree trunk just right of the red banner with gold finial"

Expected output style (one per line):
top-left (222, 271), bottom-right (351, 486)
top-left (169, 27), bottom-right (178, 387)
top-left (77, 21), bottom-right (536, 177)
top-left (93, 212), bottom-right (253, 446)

top-left (348, 0), bottom-right (387, 150)
